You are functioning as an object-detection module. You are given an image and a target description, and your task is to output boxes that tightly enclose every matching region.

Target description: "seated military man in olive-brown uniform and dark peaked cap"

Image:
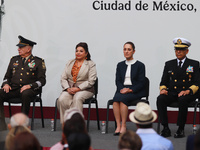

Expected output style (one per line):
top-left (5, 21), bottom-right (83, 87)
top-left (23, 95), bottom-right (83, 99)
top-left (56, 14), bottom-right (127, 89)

top-left (0, 36), bottom-right (46, 130)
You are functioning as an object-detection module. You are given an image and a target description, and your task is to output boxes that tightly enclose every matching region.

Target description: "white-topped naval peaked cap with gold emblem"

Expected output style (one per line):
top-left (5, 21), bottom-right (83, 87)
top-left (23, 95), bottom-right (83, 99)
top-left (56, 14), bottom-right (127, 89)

top-left (173, 37), bottom-right (191, 48)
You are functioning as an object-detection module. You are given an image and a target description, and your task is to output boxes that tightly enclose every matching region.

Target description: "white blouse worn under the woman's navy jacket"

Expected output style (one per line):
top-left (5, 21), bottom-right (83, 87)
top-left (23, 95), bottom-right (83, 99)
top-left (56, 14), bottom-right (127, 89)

top-left (124, 59), bottom-right (137, 85)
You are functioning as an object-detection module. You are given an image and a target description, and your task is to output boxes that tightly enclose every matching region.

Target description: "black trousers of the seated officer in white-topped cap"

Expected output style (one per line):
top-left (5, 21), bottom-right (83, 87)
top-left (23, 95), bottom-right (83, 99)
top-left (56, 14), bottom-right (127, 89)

top-left (157, 94), bottom-right (197, 128)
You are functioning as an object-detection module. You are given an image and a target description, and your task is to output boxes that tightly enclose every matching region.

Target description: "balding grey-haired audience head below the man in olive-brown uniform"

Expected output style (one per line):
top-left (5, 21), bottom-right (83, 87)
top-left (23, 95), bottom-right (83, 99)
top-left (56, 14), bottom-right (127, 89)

top-left (8, 113), bottom-right (29, 130)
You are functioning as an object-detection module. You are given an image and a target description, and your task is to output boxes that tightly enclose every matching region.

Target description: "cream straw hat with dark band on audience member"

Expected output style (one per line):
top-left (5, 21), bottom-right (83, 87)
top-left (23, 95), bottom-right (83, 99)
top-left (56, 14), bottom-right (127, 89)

top-left (129, 102), bottom-right (157, 124)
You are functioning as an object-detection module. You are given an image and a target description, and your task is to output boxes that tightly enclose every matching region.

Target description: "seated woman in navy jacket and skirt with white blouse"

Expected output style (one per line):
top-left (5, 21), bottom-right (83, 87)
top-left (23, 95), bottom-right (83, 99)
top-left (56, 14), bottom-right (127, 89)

top-left (113, 42), bottom-right (145, 136)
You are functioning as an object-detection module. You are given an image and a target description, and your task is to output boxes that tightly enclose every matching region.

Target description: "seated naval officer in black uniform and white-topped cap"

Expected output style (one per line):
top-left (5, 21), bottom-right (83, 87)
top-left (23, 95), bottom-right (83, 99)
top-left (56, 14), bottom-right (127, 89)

top-left (157, 38), bottom-right (200, 138)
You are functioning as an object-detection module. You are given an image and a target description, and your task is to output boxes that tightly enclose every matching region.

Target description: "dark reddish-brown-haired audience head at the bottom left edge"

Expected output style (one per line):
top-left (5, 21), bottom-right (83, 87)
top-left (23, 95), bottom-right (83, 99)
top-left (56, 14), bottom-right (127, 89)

top-left (10, 132), bottom-right (41, 150)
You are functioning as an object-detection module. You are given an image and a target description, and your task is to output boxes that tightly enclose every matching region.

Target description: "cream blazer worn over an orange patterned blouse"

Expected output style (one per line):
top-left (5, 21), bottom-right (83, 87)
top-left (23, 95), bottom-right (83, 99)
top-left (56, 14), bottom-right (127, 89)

top-left (61, 59), bottom-right (97, 91)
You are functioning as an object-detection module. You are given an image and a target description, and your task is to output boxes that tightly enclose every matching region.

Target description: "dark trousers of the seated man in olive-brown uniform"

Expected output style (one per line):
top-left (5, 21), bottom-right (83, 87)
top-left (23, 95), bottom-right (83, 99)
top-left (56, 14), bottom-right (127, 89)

top-left (0, 89), bottom-right (39, 119)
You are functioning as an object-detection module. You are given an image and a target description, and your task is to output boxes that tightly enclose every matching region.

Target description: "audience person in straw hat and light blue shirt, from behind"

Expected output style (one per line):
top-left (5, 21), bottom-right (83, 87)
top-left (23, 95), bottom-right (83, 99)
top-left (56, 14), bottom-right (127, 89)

top-left (129, 102), bottom-right (174, 150)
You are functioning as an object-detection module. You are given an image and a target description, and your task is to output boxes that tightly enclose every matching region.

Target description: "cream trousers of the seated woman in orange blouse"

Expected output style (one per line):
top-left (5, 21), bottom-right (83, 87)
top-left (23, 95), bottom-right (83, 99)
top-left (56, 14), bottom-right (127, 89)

top-left (57, 91), bottom-right (94, 124)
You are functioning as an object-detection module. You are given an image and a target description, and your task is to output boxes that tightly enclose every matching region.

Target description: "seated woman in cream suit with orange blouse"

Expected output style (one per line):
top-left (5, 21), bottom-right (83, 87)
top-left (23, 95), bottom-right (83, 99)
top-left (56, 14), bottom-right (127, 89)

top-left (57, 43), bottom-right (97, 123)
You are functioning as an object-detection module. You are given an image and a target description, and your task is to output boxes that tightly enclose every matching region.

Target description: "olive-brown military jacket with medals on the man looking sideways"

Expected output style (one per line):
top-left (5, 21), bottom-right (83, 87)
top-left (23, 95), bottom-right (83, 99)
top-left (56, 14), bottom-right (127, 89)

top-left (2, 55), bottom-right (46, 90)
